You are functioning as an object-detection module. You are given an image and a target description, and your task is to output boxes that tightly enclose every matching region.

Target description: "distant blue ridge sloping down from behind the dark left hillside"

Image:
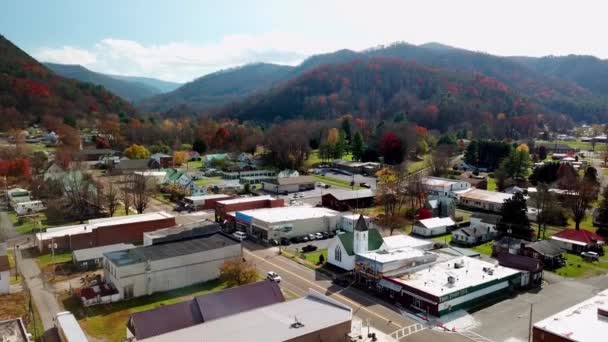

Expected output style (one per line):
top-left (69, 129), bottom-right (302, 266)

top-left (44, 63), bottom-right (161, 102)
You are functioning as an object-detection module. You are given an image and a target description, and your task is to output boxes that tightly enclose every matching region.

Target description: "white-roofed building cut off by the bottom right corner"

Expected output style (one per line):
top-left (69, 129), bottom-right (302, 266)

top-left (532, 290), bottom-right (608, 342)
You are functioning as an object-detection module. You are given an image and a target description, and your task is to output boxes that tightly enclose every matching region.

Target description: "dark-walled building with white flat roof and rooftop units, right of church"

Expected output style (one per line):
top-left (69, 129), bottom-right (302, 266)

top-left (379, 256), bottom-right (521, 316)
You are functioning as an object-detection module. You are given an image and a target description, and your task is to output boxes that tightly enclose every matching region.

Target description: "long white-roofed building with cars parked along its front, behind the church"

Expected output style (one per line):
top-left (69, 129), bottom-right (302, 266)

top-left (234, 206), bottom-right (340, 241)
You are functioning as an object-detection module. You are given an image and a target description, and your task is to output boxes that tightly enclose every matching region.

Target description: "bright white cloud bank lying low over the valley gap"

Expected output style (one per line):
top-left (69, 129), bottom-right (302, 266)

top-left (34, 33), bottom-right (352, 82)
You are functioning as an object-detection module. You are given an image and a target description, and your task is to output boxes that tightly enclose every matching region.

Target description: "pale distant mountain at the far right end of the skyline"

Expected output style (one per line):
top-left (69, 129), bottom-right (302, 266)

top-left (511, 55), bottom-right (608, 95)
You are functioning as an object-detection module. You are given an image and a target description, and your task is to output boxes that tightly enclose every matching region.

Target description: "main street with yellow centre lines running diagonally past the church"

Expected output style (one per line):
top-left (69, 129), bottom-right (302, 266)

top-left (244, 242), bottom-right (469, 342)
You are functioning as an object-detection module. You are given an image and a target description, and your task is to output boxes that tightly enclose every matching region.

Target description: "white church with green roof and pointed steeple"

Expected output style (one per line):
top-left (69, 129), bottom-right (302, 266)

top-left (327, 215), bottom-right (384, 271)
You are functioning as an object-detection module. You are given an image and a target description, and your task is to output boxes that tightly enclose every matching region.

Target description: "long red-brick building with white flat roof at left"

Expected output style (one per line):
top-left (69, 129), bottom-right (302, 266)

top-left (36, 211), bottom-right (175, 253)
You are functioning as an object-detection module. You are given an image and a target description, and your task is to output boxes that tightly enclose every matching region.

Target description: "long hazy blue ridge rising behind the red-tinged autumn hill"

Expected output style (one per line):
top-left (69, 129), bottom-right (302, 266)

top-left (140, 43), bottom-right (608, 122)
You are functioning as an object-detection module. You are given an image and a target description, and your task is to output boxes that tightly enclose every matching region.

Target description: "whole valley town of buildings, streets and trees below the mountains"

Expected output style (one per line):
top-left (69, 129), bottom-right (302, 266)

top-left (0, 119), bottom-right (608, 341)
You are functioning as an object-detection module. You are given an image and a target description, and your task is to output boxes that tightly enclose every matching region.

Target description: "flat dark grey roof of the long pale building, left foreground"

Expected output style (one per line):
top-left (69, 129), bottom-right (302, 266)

top-left (104, 233), bottom-right (240, 267)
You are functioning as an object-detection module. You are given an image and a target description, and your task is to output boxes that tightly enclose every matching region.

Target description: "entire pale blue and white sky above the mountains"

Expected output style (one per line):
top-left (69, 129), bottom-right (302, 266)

top-left (0, 0), bottom-right (608, 82)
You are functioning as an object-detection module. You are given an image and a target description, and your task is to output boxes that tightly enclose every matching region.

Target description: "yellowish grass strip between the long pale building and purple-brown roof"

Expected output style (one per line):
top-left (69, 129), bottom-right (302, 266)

top-left (63, 280), bottom-right (226, 342)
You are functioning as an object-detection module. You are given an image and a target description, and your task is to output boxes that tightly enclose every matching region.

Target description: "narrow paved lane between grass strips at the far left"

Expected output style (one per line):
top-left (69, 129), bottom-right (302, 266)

top-left (15, 249), bottom-right (63, 331)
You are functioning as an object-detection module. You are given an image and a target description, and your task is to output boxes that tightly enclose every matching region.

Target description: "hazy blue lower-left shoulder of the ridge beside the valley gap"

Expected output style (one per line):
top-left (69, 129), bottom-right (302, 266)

top-left (139, 63), bottom-right (293, 112)
